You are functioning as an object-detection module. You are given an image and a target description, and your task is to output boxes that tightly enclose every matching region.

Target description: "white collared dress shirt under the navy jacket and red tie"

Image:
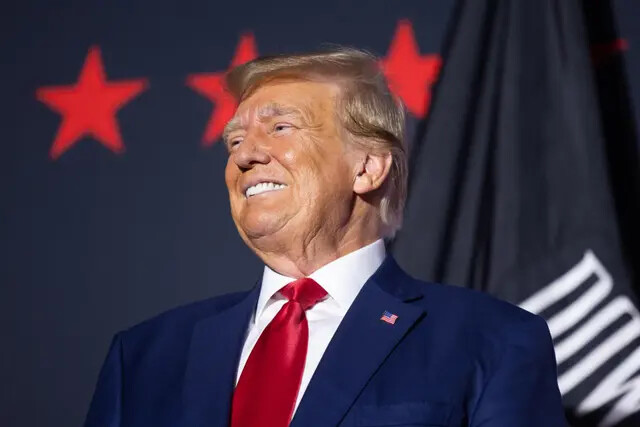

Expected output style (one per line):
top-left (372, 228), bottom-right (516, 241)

top-left (236, 239), bottom-right (386, 413)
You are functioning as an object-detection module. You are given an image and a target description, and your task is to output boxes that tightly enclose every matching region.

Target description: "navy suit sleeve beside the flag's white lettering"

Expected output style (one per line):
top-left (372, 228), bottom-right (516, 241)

top-left (469, 316), bottom-right (567, 427)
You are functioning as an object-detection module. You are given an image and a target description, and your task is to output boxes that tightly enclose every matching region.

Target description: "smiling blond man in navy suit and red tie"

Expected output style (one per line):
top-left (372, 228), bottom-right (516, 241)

top-left (86, 49), bottom-right (564, 427)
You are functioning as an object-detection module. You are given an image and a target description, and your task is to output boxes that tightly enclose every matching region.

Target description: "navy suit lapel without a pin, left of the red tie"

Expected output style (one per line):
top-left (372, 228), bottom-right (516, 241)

top-left (181, 286), bottom-right (260, 427)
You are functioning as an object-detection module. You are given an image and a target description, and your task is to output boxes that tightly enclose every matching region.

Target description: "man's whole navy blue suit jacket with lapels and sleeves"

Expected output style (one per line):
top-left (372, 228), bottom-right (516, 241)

top-left (86, 257), bottom-right (565, 427)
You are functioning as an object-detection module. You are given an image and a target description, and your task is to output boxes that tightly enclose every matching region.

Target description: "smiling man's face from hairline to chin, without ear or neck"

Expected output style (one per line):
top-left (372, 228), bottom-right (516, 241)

top-left (225, 81), bottom-right (355, 246)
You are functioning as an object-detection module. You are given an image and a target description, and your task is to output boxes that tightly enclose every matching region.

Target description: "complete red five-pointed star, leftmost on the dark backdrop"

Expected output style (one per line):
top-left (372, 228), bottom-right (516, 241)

top-left (36, 46), bottom-right (147, 159)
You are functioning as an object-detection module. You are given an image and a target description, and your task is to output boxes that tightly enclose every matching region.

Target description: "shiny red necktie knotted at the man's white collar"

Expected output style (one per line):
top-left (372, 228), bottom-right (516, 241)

top-left (231, 277), bottom-right (327, 427)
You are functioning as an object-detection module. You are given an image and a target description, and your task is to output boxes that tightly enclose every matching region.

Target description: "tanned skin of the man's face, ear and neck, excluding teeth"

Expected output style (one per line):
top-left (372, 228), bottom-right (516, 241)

top-left (225, 81), bottom-right (391, 278)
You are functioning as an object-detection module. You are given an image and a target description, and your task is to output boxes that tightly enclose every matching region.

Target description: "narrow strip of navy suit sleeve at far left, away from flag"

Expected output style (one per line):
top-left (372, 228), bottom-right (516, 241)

top-left (84, 334), bottom-right (123, 427)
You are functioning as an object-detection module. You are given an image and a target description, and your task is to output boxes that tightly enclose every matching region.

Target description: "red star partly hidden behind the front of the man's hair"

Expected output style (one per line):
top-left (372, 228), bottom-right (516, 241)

top-left (187, 33), bottom-right (258, 146)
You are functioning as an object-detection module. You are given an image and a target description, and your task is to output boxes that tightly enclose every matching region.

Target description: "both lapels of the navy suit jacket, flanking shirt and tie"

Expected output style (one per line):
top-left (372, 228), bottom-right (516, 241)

top-left (182, 256), bottom-right (425, 427)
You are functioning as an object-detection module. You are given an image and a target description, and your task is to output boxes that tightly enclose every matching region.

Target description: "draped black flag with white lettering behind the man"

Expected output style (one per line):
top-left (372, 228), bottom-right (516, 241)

top-left (393, 0), bottom-right (640, 426)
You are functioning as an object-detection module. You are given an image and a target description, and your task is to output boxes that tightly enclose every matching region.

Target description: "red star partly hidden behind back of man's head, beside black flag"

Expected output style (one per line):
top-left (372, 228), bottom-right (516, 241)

top-left (381, 20), bottom-right (442, 117)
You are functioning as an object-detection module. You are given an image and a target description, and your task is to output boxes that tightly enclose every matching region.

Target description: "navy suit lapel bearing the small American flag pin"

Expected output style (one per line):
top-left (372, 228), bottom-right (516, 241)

top-left (291, 257), bottom-right (425, 427)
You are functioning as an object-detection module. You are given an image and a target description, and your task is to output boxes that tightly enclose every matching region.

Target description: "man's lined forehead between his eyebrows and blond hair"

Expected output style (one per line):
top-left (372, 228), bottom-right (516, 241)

top-left (234, 81), bottom-right (338, 124)
